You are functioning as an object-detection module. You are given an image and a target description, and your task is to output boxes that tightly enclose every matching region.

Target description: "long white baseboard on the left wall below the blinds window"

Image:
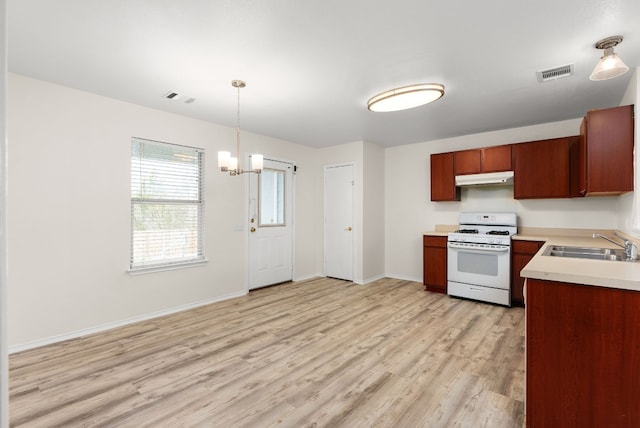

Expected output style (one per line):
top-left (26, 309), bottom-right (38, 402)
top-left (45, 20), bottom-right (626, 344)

top-left (9, 292), bottom-right (246, 354)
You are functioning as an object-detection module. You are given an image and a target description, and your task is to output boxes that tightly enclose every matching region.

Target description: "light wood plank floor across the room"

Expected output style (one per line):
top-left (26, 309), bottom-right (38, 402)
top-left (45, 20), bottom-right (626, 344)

top-left (10, 278), bottom-right (524, 428)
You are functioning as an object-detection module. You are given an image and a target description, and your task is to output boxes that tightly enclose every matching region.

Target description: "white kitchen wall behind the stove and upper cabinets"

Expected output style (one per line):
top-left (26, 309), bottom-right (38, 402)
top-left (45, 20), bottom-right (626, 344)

top-left (385, 118), bottom-right (618, 281)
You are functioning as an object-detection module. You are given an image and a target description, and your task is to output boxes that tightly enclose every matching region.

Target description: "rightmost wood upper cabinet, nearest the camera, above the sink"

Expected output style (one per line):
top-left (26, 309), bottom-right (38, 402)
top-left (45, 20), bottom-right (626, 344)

top-left (572, 105), bottom-right (634, 196)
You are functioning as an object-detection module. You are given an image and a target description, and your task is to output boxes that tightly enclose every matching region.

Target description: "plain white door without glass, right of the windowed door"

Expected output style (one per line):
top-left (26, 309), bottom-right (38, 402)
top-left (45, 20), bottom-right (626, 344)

top-left (324, 165), bottom-right (355, 281)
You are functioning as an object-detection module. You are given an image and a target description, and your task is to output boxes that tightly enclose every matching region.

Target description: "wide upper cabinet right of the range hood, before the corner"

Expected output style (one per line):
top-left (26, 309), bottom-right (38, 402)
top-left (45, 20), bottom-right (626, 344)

top-left (512, 136), bottom-right (580, 199)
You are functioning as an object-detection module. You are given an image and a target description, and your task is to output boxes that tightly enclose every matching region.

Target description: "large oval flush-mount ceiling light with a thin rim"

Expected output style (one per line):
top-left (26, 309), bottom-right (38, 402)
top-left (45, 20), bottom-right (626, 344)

top-left (367, 83), bottom-right (444, 112)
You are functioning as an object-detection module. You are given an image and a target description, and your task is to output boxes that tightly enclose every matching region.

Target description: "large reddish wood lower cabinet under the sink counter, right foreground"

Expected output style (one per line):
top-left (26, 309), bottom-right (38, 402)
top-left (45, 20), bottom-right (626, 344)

top-left (525, 279), bottom-right (640, 428)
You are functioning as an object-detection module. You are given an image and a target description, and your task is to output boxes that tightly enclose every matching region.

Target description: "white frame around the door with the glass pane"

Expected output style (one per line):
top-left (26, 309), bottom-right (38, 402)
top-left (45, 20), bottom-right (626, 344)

top-left (242, 154), bottom-right (297, 294)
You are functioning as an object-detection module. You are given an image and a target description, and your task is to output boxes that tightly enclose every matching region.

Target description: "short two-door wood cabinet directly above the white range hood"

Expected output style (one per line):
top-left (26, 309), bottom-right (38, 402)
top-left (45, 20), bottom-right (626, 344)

top-left (454, 145), bottom-right (511, 175)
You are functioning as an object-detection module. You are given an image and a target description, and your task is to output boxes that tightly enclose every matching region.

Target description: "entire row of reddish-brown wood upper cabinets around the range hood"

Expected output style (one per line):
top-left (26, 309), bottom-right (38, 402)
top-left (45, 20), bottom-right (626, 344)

top-left (431, 105), bottom-right (634, 201)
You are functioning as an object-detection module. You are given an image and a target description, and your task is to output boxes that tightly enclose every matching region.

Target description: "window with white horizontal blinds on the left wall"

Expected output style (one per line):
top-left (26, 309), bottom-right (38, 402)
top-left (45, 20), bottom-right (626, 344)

top-left (130, 138), bottom-right (204, 271)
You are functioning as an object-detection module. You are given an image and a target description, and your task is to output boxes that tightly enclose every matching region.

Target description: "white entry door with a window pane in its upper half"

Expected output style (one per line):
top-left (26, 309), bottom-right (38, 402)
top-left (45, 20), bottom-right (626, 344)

top-left (249, 158), bottom-right (294, 290)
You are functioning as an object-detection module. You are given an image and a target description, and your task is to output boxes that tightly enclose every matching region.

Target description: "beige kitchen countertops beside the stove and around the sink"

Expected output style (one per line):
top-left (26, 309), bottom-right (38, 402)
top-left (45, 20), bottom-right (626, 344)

top-left (424, 225), bottom-right (640, 291)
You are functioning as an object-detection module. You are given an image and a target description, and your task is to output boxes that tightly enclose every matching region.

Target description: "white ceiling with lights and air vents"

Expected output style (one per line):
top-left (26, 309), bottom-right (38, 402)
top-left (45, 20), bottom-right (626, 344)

top-left (7, 0), bottom-right (640, 147)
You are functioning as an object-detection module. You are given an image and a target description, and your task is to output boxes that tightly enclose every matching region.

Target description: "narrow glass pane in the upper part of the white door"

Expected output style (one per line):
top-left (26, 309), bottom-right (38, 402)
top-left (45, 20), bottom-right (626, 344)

top-left (258, 169), bottom-right (285, 227)
